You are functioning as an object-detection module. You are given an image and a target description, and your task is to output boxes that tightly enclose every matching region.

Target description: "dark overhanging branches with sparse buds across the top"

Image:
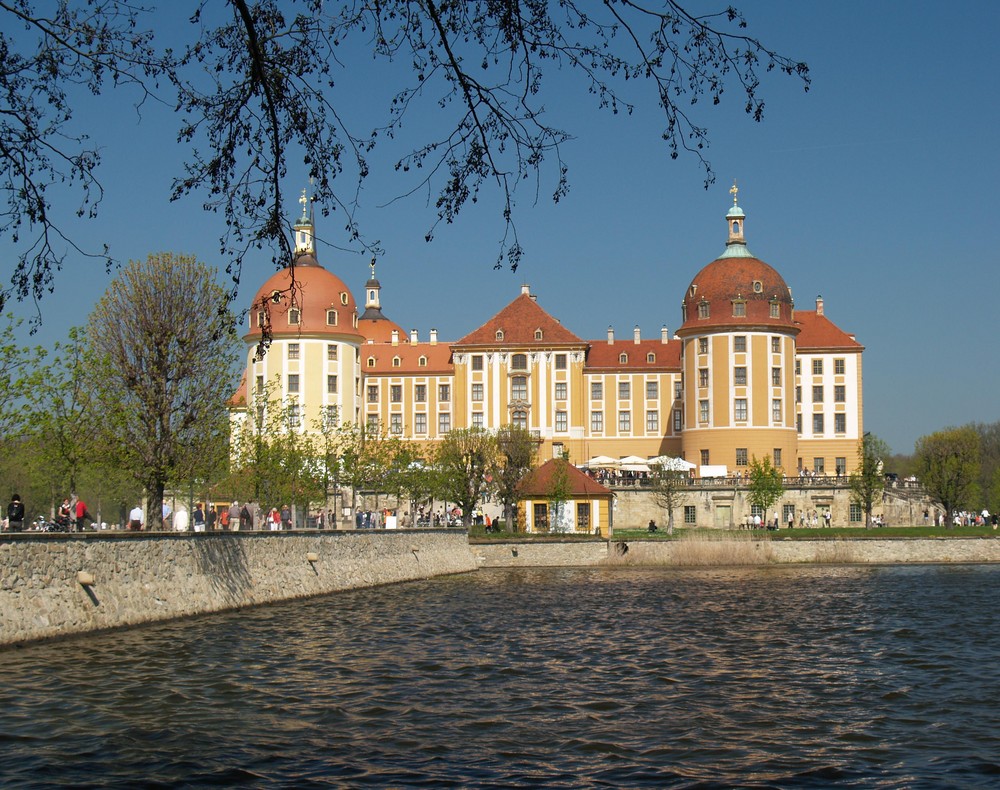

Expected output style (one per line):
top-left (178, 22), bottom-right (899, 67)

top-left (0, 0), bottom-right (809, 318)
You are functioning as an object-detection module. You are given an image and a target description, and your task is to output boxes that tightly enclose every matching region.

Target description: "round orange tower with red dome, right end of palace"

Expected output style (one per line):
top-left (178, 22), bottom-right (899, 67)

top-left (677, 184), bottom-right (799, 475)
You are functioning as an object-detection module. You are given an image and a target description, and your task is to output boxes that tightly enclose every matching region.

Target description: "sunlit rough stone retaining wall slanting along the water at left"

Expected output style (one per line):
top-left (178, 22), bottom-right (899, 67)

top-left (0, 530), bottom-right (477, 645)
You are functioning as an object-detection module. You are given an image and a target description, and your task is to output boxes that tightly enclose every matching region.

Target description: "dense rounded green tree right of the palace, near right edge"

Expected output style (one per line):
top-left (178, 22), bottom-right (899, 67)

top-left (914, 426), bottom-right (981, 524)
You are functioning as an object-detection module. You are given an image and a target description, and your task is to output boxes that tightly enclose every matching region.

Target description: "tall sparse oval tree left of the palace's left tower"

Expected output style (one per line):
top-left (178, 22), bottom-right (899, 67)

top-left (87, 253), bottom-right (239, 523)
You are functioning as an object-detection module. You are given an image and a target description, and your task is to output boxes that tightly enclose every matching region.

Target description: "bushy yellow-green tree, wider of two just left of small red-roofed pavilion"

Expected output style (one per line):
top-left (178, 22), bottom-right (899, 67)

top-left (434, 428), bottom-right (497, 528)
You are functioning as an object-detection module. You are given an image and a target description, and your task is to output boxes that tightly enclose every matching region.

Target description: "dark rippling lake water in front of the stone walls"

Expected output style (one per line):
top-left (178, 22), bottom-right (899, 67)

top-left (0, 566), bottom-right (1000, 788)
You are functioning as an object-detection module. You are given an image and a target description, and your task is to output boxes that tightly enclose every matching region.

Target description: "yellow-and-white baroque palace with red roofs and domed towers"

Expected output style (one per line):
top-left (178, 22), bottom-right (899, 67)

top-left (231, 187), bottom-right (864, 476)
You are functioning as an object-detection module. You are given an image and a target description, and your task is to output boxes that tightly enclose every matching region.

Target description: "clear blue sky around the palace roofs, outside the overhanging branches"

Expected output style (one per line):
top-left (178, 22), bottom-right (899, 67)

top-left (0, 0), bottom-right (1000, 452)
